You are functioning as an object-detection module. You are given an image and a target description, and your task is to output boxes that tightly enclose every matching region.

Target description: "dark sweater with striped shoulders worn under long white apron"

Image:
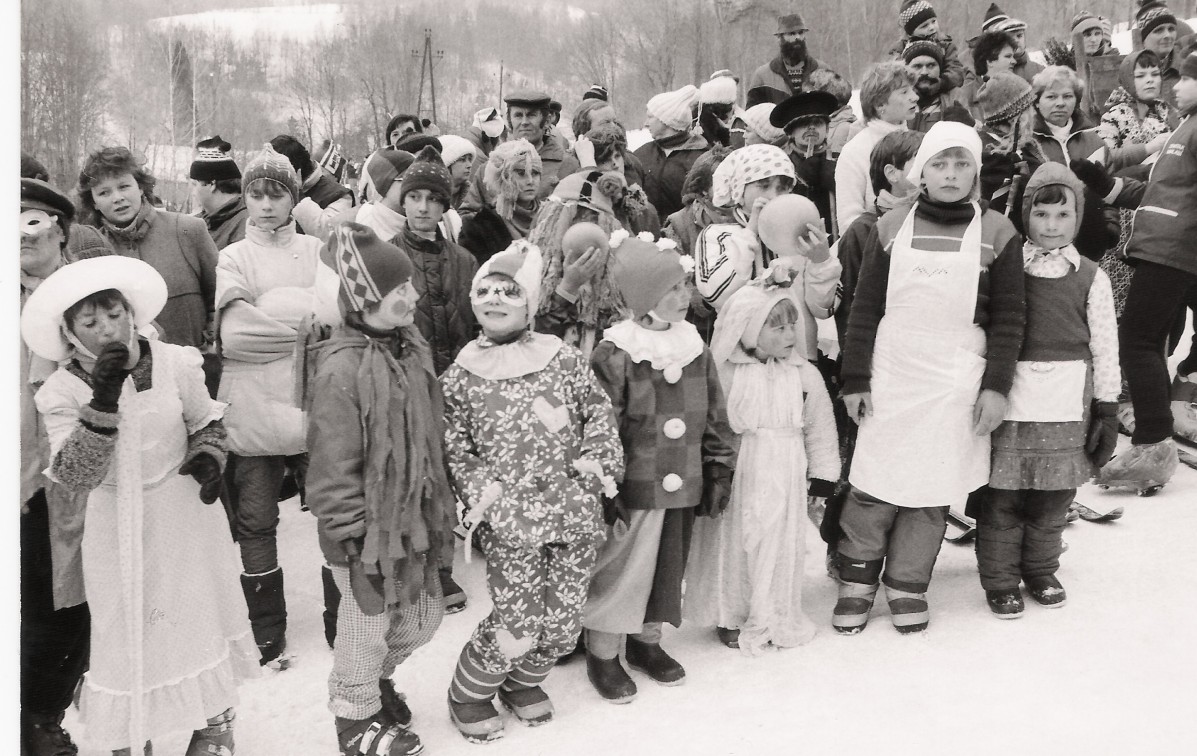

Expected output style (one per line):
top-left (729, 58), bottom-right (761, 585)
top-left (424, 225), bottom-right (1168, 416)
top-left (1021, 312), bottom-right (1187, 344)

top-left (840, 196), bottom-right (1026, 395)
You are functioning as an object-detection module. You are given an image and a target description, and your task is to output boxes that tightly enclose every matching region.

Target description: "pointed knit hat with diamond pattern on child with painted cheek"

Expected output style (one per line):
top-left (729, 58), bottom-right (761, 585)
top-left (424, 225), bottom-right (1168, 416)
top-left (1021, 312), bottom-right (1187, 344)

top-left (320, 221), bottom-right (415, 315)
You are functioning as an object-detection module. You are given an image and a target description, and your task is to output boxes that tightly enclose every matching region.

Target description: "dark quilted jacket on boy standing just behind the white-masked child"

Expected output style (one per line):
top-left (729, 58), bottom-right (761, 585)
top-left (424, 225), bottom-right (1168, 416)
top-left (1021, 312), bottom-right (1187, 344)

top-left (390, 230), bottom-right (478, 376)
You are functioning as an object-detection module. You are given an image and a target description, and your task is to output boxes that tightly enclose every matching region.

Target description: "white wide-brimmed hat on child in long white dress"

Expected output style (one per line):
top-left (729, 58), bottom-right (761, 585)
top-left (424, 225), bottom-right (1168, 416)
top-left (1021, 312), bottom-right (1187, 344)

top-left (20, 255), bottom-right (166, 362)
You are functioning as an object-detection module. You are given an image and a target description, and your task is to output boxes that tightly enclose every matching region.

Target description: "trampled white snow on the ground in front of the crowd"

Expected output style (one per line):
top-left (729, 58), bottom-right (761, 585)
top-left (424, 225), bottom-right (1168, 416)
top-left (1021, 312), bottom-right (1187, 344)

top-left (67, 439), bottom-right (1197, 756)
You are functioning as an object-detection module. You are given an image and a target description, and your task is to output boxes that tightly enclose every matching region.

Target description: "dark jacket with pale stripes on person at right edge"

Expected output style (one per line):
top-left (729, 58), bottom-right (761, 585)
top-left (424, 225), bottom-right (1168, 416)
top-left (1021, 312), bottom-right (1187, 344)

top-left (1126, 112), bottom-right (1197, 275)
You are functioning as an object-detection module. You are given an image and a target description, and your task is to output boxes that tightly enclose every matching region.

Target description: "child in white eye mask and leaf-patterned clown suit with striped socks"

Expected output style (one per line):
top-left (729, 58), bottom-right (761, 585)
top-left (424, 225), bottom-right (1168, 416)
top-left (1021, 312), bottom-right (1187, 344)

top-left (440, 240), bottom-right (624, 743)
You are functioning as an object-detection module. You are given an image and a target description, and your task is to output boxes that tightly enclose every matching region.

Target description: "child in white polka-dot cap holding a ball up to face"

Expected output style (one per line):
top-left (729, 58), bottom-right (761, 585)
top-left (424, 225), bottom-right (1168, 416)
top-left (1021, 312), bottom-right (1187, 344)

top-left (694, 145), bottom-right (840, 360)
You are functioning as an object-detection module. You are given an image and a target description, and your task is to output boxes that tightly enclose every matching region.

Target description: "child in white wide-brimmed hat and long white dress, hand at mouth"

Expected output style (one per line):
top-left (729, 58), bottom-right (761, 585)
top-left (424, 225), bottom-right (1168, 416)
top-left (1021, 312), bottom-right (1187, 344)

top-left (22, 257), bottom-right (259, 756)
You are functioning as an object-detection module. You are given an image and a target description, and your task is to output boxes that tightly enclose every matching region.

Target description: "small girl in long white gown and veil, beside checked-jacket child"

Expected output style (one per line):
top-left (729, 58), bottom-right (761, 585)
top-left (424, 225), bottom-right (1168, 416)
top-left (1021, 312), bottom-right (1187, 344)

top-left (685, 269), bottom-right (839, 654)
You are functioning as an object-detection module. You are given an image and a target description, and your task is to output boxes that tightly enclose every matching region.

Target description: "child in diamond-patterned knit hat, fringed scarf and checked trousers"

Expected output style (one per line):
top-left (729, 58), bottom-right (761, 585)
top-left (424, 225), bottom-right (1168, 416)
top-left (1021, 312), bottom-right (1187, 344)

top-left (304, 222), bottom-right (454, 756)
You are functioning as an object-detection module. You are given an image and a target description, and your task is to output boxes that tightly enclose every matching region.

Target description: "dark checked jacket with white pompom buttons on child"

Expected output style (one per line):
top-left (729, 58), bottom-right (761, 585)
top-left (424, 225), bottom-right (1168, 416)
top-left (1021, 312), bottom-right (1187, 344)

top-left (590, 341), bottom-right (735, 510)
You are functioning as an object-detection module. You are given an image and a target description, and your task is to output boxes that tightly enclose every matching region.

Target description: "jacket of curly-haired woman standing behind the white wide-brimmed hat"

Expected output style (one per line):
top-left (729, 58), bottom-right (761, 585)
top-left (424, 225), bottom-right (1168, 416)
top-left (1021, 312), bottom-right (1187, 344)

top-left (99, 207), bottom-right (217, 347)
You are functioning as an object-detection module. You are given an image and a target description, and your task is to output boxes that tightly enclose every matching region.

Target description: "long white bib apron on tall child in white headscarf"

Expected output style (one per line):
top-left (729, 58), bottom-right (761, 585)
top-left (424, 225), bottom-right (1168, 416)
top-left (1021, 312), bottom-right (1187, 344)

top-left (849, 203), bottom-right (990, 507)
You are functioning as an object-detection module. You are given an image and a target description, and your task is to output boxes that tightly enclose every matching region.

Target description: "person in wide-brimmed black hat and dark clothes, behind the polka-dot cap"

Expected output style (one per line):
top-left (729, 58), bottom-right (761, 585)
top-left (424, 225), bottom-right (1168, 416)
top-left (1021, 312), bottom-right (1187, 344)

top-left (768, 92), bottom-right (839, 234)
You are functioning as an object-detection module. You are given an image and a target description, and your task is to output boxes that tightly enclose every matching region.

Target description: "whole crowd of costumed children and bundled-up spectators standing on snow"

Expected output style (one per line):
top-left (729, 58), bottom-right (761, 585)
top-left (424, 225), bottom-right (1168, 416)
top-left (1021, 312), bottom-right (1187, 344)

top-left (20, 0), bottom-right (1197, 756)
